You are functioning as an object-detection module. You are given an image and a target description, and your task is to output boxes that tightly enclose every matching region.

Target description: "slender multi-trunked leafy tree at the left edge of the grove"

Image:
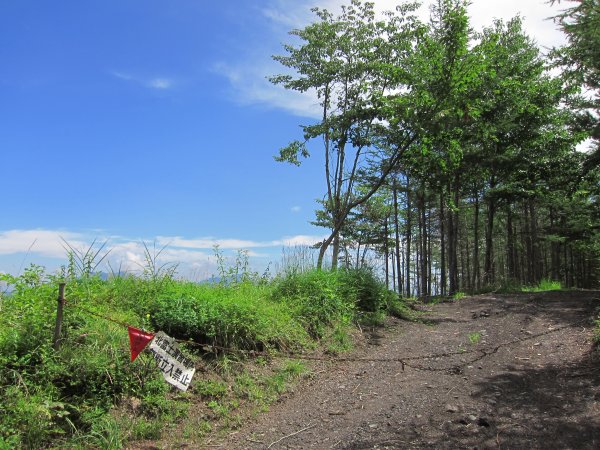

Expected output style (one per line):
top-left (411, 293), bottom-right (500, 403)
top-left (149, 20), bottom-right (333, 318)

top-left (271, 1), bottom-right (420, 268)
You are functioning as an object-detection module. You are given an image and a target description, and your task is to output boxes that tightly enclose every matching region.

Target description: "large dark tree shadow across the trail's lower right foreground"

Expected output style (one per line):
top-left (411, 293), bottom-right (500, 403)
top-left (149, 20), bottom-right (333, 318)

top-left (340, 354), bottom-right (600, 450)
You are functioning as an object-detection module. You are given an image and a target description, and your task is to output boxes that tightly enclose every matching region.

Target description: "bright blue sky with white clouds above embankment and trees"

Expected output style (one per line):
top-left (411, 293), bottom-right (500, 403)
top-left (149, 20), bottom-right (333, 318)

top-left (0, 0), bottom-right (562, 279)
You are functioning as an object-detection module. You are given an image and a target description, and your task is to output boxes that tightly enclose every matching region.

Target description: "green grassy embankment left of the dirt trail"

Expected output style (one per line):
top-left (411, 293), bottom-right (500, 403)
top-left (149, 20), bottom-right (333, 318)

top-left (0, 256), bottom-right (407, 449)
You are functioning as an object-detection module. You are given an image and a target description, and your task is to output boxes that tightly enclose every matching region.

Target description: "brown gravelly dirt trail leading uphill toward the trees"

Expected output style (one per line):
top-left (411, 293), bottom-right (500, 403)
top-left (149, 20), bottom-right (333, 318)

top-left (221, 291), bottom-right (600, 450)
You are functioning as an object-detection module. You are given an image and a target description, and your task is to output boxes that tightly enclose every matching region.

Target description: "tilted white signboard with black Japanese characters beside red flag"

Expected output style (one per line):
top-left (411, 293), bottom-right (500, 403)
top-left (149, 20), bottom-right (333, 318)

top-left (148, 331), bottom-right (196, 391)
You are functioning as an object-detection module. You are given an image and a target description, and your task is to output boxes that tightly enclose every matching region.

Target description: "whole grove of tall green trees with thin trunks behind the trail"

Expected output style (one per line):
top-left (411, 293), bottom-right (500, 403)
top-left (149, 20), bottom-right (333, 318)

top-left (271, 0), bottom-right (600, 295)
